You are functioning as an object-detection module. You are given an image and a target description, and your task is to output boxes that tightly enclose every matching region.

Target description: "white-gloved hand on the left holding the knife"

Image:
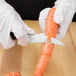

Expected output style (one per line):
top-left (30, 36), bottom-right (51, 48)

top-left (0, 0), bottom-right (34, 49)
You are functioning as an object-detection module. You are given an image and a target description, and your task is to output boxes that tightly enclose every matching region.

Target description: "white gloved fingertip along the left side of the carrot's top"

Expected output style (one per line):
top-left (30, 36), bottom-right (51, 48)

top-left (39, 8), bottom-right (50, 32)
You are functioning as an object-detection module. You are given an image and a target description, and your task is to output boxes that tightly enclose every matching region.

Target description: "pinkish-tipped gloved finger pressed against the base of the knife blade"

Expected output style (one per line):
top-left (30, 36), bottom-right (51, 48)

top-left (12, 14), bottom-right (29, 46)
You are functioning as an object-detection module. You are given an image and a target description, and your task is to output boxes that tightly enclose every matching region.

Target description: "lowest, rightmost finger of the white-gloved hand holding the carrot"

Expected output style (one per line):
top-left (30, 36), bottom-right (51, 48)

top-left (56, 9), bottom-right (75, 40)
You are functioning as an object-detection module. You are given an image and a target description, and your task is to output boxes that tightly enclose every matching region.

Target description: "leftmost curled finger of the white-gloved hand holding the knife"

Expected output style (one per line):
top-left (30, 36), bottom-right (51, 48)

top-left (0, 14), bottom-right (15, 49)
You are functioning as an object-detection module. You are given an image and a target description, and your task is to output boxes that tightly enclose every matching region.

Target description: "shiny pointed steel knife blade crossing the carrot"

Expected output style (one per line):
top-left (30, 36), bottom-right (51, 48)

top-left (29, 33), bottom-right (64, 46)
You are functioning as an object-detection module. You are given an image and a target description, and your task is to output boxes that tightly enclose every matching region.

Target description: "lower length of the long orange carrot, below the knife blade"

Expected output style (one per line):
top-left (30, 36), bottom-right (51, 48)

top-left (34, 42), bottom-right (52, 76)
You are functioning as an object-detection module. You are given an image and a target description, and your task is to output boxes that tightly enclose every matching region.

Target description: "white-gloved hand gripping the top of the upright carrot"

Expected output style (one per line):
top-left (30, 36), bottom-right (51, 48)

top-left (39, 0), bottom-right (76, 40)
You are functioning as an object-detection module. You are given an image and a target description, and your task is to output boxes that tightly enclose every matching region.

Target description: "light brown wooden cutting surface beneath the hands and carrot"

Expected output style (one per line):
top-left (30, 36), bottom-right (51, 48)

top-left (0, 21), bottom-right (76, 76)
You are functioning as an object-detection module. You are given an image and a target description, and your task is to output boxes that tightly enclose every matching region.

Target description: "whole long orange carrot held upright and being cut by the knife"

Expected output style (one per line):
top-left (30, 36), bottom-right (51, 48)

top-left (34, 7), bottom-right (58, 76)
